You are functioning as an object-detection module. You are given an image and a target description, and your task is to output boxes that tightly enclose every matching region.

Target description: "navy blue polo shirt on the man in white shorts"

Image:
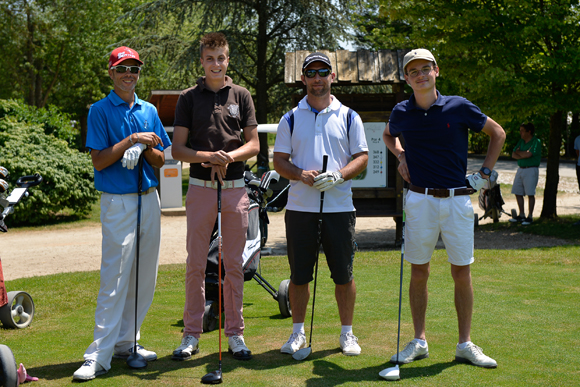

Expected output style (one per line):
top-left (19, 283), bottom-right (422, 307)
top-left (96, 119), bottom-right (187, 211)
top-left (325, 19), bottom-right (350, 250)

top-left (389, 91), bottom-right (487, 188)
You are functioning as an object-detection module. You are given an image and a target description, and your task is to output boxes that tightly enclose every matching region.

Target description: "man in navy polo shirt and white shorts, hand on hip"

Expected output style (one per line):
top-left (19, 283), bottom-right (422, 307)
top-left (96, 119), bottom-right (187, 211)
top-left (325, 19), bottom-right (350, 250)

top-left (383, 49), bottom-right (505, 368)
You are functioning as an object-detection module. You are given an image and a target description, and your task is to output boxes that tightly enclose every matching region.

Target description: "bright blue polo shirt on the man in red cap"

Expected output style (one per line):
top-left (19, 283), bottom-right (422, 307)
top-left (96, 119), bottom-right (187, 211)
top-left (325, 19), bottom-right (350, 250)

top-left (86, 90), bottom-right (171, 194)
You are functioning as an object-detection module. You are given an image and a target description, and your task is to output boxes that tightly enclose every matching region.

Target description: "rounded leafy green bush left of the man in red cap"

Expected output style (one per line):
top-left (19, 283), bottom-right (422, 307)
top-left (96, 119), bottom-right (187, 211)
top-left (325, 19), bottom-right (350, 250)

top-left (0, 101), bottom-right (98, 226)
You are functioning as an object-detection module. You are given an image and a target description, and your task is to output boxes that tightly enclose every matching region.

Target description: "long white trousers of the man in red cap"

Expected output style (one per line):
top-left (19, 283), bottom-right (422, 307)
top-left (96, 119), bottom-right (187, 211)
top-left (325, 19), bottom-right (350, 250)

top-left (84, 191), bottom-right (161, 370)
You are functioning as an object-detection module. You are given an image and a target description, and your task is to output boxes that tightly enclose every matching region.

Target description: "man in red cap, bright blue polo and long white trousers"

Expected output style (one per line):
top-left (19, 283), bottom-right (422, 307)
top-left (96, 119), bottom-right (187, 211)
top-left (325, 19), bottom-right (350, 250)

top-left (73, 47), bottom-right (171, 380)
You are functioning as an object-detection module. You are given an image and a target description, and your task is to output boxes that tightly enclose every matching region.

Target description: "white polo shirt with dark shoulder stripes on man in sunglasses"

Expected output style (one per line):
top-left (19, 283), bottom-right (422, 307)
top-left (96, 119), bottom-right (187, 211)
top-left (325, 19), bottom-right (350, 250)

top-left (274, 96), bottom-right (368, 213)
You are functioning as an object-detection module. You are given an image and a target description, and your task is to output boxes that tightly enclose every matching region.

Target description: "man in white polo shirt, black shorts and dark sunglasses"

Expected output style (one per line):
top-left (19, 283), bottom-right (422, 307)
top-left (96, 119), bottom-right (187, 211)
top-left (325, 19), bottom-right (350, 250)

top-left (274, 52), bottom-right (368, 356)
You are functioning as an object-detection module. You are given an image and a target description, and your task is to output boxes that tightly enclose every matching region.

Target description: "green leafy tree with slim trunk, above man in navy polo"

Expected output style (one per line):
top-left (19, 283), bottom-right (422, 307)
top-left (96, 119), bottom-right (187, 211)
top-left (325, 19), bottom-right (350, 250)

top-left (362, 0), bottom-right (580, 218)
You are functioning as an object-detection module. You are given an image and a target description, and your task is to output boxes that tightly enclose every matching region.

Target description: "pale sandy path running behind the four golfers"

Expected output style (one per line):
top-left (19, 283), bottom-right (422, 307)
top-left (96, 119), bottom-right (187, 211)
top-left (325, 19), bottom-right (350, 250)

top-left (0, 194), bottom-right (580, 280)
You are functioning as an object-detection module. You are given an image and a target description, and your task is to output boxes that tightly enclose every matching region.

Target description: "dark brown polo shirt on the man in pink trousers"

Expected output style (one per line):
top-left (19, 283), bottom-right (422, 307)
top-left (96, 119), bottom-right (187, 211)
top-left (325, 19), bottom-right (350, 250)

top-left (173, 75), bottom-right (258, 180)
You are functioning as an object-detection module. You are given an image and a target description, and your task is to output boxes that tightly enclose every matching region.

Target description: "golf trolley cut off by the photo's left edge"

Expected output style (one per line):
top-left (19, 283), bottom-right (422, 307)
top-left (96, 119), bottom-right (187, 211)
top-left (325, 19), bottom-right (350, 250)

top-left (0, 167), bottom-right (42, 387)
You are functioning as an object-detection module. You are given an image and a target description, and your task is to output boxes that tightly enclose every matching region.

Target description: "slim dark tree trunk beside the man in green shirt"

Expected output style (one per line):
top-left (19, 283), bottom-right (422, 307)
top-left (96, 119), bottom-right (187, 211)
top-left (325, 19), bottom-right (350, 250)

top-left (540, 111), bottom-right (564, 219)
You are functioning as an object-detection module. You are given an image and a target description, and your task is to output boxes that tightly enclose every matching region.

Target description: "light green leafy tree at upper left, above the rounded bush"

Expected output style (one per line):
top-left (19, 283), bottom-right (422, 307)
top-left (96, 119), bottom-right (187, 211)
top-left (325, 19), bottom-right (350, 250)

top-left (0, 0), bottom-right (152, 148)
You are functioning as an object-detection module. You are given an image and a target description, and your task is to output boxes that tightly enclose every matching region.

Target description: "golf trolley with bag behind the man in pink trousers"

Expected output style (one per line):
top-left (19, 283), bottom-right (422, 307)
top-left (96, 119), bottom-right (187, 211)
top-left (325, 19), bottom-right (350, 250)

top-left (203, 171), bottom-right (292, 332)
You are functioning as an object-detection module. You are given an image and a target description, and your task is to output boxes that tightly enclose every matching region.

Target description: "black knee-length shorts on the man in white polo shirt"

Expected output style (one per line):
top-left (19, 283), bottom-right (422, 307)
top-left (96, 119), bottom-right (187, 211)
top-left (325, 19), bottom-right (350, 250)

top-left (284, 210), bottom-right (356, 285)
